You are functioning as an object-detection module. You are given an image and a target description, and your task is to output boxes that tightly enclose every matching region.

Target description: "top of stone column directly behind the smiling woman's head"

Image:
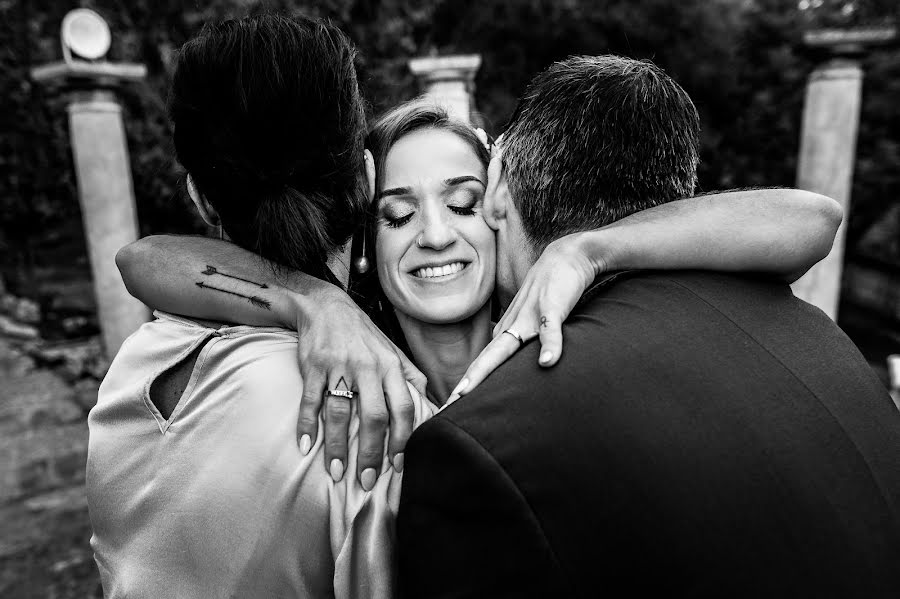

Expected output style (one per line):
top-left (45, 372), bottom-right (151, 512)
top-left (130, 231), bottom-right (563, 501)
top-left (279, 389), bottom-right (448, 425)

top-left (409, 54), bottom-right (481, 123)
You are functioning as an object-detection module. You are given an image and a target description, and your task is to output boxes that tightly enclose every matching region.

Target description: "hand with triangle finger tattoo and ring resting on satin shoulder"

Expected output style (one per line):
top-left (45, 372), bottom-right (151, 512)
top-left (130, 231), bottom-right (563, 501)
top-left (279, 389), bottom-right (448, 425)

top-left (295, 286), bottom-right (425, 491)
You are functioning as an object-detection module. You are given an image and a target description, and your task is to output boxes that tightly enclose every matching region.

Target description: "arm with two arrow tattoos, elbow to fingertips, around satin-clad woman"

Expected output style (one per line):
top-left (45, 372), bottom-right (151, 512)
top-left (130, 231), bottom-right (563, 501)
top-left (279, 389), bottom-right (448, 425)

top-left (116, 235), bottom-right (425, 482)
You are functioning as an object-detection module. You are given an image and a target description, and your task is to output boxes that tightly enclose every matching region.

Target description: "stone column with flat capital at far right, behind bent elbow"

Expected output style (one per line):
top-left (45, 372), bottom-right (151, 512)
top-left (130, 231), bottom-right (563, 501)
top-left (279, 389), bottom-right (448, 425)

top-left (792, 28), bottom-right (896, 319)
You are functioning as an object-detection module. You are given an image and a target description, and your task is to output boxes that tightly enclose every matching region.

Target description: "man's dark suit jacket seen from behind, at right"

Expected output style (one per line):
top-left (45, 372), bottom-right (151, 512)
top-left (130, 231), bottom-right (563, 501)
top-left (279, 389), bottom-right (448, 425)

top-left (398, 272), bottom-right (900, 599)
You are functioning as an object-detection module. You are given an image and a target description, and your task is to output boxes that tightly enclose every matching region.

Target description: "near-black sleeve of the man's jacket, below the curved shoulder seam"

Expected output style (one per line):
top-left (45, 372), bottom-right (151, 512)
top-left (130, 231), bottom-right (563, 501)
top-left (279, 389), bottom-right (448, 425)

top-left (397, 416), bottom-right (571, 598)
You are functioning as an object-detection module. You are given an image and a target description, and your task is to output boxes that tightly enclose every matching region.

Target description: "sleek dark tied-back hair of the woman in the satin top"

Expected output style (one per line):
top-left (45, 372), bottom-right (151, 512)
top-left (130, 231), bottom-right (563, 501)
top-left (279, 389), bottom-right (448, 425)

top-left (169, 14), bottom-right (366, 282)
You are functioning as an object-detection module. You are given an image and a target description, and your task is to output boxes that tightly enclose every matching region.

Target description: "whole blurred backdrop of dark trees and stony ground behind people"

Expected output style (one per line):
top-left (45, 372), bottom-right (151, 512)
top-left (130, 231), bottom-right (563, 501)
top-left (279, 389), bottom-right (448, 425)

top-left (0, 0), bottom-right (900, 597)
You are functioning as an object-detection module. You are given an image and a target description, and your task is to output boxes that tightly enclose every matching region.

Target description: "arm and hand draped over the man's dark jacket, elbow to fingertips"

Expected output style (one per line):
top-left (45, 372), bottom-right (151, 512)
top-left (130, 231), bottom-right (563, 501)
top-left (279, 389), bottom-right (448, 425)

top-left (449, 189), bottom-right (843, 401)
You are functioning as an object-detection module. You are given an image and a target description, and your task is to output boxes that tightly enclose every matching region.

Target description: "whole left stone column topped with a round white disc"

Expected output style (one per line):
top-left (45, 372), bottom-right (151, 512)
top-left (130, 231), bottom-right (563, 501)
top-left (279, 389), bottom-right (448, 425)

top-left (31, 9), bottom-right (149, 358)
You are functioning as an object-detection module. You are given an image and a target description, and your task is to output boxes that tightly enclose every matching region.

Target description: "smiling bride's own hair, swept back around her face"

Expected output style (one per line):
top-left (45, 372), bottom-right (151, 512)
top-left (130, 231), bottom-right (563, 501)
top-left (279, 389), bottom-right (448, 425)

top-left (353, 98), bottom-right (491, 354)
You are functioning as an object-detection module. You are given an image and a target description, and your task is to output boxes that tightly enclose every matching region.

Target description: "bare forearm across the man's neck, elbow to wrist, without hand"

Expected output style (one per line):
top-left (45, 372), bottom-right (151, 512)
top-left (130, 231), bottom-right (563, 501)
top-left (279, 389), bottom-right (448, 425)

top-left (580, 189), bottom-right (843, 283)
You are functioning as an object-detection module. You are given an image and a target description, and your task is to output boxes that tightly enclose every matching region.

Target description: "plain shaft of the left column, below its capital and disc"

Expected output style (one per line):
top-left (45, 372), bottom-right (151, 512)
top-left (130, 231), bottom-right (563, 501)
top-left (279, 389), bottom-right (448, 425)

top-left (69, 90), bottom-right (149, 357)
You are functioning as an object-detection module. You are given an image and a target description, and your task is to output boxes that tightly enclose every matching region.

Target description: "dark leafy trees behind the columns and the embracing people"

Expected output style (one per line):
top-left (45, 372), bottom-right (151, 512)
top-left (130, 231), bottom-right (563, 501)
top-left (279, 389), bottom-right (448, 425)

top-left (0, 0), bottom-right (900, 276)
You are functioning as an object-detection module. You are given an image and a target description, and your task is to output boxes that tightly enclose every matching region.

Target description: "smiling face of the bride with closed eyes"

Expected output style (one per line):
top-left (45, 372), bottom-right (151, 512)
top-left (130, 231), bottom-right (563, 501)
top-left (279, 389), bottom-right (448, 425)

top-left (375, 129), bottom-right (496, 324)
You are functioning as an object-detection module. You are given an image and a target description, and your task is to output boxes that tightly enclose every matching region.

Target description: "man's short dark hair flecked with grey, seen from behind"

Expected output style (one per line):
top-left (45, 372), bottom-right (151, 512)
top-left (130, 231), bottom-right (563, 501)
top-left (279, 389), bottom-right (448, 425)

top-left (501, 55), bottom-right (700, 250)
